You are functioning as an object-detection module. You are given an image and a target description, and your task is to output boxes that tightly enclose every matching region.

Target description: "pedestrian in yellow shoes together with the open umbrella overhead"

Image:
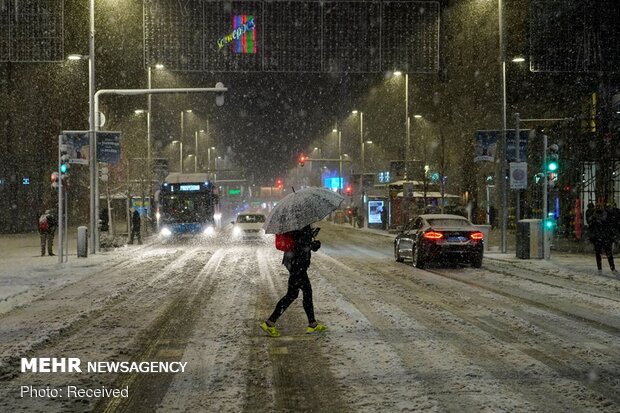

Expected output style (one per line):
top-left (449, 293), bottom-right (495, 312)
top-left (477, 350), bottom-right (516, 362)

top-left (260, 188), bottom-right (344, 337)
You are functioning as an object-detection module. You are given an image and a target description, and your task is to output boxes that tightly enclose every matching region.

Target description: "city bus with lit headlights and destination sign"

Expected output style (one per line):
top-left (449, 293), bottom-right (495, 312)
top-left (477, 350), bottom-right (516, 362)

top-left (155, 173), bottom-right (221, 238)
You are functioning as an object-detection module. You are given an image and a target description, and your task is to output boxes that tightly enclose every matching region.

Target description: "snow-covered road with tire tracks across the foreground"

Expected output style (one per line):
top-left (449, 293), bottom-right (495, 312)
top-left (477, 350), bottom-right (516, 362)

top-left (0, 224), bottom-right (620, 412)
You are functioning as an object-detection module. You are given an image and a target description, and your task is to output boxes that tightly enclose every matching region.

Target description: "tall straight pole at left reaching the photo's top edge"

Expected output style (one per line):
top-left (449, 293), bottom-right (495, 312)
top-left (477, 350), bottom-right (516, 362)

top-left (88, 0), bottom-right (97, 254)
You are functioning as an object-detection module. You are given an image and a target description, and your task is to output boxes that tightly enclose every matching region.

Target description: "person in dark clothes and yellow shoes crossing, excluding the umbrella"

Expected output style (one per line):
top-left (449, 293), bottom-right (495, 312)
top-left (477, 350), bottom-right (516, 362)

top-left (261, 225), bottom-right (327, 337)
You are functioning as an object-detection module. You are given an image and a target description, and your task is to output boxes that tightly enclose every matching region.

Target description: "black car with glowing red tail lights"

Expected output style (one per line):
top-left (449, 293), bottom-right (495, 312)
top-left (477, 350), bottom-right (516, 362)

top-left (394, 214), bottom-right (484, 268)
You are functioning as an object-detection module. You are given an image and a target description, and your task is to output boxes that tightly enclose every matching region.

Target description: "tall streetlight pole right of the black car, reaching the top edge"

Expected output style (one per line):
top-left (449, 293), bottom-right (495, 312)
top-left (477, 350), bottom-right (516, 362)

top-left (497, 0), bottom-right (508, 254)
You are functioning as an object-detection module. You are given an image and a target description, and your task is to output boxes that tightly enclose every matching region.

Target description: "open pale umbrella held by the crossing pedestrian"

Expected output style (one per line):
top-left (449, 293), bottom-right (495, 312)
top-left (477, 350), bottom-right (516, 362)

top-left (263, 187), bottom-right (344, 234)
